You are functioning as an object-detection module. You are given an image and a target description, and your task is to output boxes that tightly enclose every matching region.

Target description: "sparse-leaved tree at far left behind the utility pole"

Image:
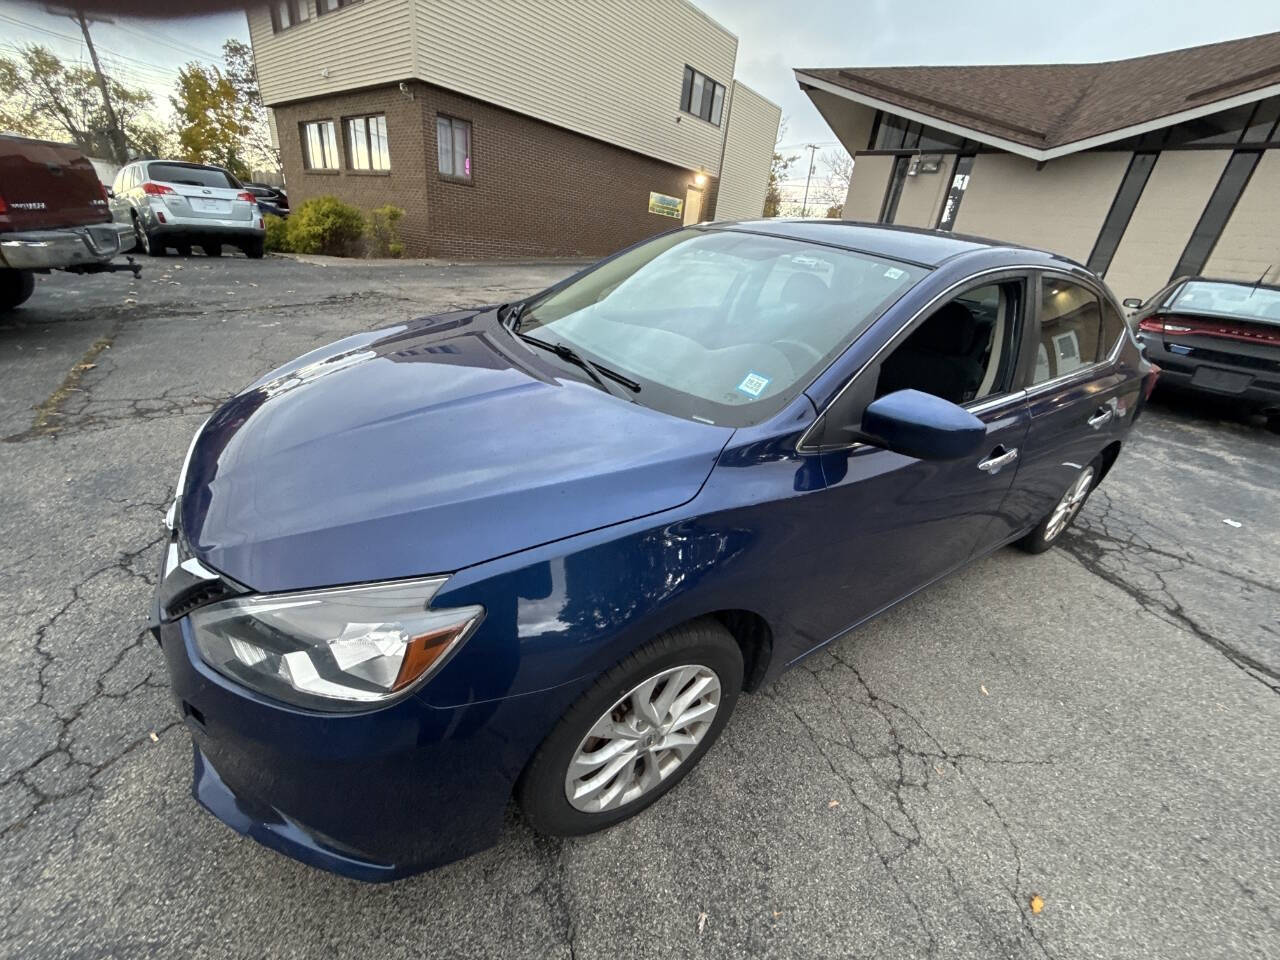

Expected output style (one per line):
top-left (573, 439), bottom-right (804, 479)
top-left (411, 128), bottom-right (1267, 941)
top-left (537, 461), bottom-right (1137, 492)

top-left (0, 45), bottom-right (166, 157)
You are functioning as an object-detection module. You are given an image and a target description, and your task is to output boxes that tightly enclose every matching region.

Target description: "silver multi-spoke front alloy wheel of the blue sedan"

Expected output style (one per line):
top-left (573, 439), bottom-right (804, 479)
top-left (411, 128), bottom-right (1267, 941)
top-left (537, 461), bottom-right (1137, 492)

top-left (564, 664), bottom-right (721, 813)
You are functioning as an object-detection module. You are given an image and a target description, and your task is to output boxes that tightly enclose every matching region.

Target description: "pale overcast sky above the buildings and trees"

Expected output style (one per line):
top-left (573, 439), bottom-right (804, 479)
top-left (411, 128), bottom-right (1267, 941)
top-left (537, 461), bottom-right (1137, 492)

top-left (0, 0), bottom-right (1280, 172)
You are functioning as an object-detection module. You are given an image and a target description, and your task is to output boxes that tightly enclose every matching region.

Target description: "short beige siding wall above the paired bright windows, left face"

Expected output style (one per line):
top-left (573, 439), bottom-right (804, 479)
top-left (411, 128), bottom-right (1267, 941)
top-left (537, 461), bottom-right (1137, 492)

top-left (247, 0), bottom-right (413, 104)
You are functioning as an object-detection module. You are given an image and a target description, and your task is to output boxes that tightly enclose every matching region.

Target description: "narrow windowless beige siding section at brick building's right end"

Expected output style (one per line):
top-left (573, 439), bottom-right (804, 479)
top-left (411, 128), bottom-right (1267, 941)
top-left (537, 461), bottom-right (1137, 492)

top-left (716, 81), bottom-right (782, 220)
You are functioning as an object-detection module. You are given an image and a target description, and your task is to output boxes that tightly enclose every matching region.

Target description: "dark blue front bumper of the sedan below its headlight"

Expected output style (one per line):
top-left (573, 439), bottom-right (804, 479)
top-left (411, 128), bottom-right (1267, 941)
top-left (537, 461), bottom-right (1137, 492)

top-left (152, 618), bottom-right (576, 882)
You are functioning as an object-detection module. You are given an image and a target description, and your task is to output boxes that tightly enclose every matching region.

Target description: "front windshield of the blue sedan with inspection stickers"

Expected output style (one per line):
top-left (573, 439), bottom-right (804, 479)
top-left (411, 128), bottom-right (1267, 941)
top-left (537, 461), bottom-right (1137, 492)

top-left (518, 228), bottom-right (927, 426)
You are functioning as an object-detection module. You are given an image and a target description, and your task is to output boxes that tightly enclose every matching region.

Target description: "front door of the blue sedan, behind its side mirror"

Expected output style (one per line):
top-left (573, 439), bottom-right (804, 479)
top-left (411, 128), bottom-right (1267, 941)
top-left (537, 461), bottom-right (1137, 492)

top-left (806, 273), bottom-right (1029, 640)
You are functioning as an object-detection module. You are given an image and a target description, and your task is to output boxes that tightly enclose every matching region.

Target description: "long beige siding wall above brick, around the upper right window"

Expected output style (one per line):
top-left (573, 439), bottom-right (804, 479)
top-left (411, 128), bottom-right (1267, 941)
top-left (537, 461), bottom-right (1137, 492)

top-left (414, 0), bottom-right (737, 177)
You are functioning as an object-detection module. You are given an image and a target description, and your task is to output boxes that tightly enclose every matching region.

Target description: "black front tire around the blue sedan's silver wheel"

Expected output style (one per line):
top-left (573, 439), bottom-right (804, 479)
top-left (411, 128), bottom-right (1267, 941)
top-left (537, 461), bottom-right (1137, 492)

top-left (516, 618), bottom-right (742, 837)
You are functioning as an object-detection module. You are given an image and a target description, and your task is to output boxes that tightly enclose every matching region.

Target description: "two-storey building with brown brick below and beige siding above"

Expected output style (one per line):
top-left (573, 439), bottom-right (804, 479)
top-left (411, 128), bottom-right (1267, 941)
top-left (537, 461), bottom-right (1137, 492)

top-left (247, 0), bottom-right (780, 257)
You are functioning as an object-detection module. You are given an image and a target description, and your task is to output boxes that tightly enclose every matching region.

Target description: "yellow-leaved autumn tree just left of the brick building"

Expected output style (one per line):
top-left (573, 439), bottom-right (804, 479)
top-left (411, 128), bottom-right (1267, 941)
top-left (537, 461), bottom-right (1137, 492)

top-left (169, 61), bottom-right (250, 179)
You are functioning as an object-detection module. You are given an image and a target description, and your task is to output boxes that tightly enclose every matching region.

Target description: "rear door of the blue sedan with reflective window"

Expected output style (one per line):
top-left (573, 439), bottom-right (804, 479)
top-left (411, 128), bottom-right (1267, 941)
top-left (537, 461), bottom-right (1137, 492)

top-left (1006, 271), bottom-right (1138, 530)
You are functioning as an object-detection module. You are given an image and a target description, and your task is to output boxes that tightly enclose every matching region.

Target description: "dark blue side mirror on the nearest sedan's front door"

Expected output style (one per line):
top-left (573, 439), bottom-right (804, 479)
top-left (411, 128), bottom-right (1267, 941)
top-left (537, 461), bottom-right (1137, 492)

top-left (859, 390), bottom-right (987, 460)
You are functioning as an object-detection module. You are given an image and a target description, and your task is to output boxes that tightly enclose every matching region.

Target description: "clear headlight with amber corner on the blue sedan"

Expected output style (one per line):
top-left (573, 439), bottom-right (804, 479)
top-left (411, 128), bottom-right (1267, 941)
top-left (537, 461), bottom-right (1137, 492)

top-left (189, 577), bottom-right (484, 710)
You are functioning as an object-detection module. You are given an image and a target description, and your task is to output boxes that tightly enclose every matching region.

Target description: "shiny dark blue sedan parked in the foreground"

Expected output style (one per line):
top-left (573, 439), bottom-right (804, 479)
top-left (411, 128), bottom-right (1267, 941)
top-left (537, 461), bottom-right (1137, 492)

top-left (154, 220), bottom-right (1151, 881)
